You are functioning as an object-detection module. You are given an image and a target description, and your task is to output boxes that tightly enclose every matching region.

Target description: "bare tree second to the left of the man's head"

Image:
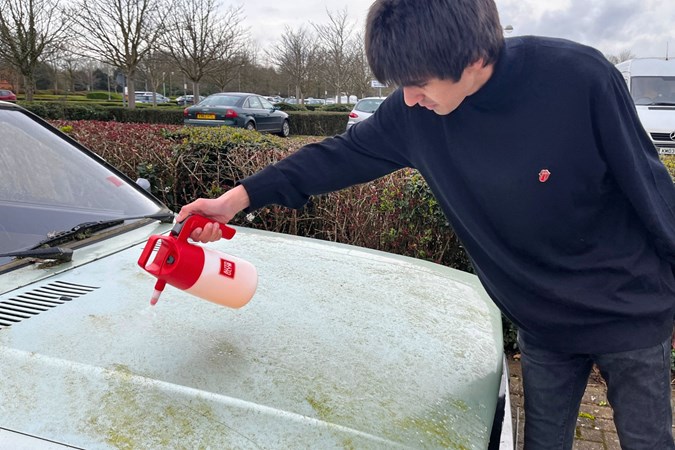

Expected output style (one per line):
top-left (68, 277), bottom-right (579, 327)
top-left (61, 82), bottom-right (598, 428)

top-left (267, 26), bottom-right (317, 101)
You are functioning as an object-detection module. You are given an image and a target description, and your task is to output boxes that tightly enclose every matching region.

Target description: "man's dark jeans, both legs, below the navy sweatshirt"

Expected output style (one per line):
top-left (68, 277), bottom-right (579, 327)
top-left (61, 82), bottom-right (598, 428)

top-left (518, 334), bottom-right (675, 450)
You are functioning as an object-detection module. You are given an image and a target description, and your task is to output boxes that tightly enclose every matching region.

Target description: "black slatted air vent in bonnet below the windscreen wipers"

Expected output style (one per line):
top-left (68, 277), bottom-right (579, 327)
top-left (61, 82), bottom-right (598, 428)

top-left (0, 281), bottom-right (98, 329)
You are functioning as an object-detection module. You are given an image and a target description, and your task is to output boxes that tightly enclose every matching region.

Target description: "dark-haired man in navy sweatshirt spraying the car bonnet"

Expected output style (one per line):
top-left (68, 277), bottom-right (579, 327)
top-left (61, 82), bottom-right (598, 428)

top-left (178, 0), bottom-right (675, 449)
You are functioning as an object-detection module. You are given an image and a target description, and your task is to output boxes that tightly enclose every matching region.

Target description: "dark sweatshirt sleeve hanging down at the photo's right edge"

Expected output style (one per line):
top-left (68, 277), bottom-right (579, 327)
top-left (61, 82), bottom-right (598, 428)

top-left (592, 68), bottom-right (675, 265)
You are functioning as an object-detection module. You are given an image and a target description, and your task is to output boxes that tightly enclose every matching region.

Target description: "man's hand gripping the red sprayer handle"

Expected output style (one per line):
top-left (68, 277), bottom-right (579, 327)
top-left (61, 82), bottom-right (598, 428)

top-left (176, 185), bottom-right (250, 242)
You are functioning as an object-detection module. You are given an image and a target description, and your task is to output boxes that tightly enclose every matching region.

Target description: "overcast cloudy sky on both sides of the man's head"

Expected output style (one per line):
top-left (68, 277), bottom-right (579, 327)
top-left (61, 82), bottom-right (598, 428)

top-left (235, 0), bottom-right (675, 57)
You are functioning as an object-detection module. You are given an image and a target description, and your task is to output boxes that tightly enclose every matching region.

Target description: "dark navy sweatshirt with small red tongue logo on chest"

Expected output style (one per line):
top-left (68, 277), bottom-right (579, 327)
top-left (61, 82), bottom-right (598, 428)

top-left (242, 37), bottom-right (675, 353)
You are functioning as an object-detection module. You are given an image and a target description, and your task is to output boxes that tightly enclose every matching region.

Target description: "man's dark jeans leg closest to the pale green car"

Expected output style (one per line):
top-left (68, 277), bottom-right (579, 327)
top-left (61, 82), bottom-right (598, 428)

top-left (518, 333), bottom-right (593, 450)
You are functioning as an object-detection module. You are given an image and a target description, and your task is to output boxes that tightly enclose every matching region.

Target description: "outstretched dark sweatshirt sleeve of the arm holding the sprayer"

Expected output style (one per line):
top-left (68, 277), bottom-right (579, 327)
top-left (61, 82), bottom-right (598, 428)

top-left (240, 94), bottom-right (409, 211)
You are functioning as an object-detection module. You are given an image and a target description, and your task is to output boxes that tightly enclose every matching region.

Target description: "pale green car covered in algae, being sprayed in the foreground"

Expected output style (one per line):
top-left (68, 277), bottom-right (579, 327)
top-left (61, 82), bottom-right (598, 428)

top-left (0, 102), bottom-right (513, 450)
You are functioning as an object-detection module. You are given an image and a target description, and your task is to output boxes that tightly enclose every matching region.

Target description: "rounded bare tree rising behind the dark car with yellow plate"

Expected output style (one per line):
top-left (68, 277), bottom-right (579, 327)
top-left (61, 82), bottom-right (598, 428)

top-left (163, 0), bottom-right (248, 99)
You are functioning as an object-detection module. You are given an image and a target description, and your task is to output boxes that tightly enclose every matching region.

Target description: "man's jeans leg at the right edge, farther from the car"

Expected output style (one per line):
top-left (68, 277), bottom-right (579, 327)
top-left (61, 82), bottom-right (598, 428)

top-left (594, 338), bottom-right (675, 450)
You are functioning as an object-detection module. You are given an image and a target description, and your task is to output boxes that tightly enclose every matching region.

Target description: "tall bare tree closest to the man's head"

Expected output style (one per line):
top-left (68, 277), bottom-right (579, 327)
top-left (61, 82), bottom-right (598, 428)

top-left (312, 8), bottom-right (362, 103)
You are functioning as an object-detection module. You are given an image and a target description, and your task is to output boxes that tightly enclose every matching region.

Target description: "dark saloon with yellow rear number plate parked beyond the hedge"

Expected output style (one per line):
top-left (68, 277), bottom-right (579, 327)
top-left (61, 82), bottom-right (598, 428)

top-left (183, 92), bottom-right (290, 137)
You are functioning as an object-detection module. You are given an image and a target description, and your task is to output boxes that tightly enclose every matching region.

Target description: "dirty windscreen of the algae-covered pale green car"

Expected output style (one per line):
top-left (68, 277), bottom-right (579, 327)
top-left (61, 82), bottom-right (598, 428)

top-left (0, 109), bottom-right (162, 264)
